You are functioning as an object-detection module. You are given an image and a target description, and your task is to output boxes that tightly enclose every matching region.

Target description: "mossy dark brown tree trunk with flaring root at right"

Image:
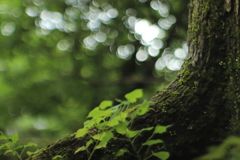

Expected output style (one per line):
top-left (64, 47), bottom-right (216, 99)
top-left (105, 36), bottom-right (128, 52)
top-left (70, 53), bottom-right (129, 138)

top-left (29, 0), bottom-right (240, 160)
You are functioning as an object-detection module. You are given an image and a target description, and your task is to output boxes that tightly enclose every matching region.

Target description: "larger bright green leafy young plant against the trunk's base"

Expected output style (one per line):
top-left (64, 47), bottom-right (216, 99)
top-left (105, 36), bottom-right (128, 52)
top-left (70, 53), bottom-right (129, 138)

top-left (75, 89), bottom-right (169, 160)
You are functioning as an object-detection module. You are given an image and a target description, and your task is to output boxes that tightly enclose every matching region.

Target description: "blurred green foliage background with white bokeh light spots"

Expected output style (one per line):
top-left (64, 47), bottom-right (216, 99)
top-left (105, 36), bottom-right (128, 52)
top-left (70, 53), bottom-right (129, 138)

top-left (0, 0), bottom-right (188, 159)
